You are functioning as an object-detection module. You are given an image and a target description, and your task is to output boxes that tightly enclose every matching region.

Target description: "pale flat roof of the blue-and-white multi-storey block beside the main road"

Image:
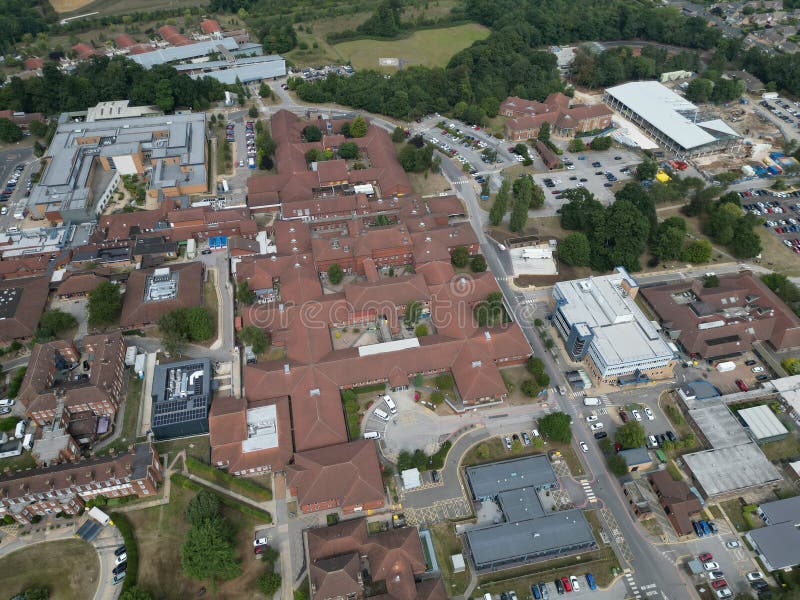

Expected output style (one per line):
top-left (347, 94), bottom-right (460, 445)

top-left (555, 267), bottom-right (674, 366)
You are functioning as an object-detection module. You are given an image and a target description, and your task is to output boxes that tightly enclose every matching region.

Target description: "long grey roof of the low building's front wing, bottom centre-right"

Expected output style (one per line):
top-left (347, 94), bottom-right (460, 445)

top-left (466, 509), bottom-right (595, 566)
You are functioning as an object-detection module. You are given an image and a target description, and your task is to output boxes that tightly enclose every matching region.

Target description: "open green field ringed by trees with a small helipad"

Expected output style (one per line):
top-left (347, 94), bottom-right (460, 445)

top-left (334, 23), bottom-right (489, 69)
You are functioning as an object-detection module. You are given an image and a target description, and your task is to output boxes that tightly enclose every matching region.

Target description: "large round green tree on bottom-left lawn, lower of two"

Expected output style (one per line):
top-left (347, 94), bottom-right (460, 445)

top-left (181, 517), bottom-right (242, 585)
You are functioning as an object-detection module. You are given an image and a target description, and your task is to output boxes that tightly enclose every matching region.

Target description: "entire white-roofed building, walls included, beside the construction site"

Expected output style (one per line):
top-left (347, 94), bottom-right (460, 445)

top-left (603, 81), bottom-right (742, 157)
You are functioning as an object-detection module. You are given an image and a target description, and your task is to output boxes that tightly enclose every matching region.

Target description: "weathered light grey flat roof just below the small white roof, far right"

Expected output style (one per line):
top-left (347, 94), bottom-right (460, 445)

top-left (683, 440), bottom-right (781, 497)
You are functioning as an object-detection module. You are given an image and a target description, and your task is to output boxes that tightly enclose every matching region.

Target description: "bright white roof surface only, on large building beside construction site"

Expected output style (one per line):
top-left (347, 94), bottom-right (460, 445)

top-left (606, 81), bottom-right (740, 150)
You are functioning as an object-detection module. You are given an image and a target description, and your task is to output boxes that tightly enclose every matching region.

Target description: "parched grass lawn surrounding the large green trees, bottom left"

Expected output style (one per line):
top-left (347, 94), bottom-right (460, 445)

top-left (127, 478), bottom-right (264, 600)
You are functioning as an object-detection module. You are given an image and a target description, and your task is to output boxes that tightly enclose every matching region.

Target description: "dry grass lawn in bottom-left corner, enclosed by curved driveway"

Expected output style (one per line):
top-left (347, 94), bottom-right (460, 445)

top-left (0, 539), bottom-right (100, 600)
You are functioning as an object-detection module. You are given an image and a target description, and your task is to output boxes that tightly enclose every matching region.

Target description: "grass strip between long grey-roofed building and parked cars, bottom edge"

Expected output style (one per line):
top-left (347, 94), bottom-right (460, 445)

top-left (474, 547), bottom-right (620, 598)
